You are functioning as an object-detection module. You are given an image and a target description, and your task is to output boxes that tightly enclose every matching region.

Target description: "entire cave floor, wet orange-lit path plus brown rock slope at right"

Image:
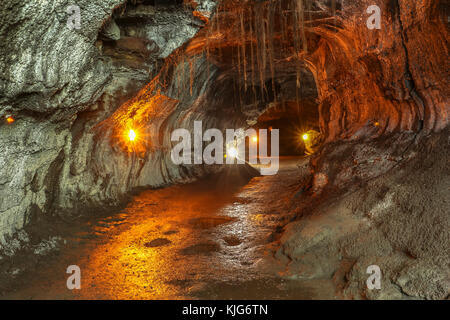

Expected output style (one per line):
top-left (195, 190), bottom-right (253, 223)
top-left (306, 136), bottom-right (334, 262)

top-left (0, 132), bottom-right (450, 299)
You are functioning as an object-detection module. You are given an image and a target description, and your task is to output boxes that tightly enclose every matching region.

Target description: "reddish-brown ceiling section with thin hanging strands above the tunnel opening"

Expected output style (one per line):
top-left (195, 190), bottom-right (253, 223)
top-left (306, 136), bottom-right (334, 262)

top-left (199, 0), bottom-right (312, 109)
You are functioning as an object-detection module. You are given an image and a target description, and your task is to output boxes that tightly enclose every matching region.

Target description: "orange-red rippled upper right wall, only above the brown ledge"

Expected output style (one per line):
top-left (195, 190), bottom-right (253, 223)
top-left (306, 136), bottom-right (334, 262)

top-left (310, 0), bottom-right (450, 141)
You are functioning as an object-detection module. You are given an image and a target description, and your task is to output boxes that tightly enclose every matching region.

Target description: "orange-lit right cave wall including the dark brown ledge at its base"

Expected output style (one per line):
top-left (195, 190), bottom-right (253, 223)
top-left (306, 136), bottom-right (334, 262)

top-left (302, 0), bottom-right (450, 193)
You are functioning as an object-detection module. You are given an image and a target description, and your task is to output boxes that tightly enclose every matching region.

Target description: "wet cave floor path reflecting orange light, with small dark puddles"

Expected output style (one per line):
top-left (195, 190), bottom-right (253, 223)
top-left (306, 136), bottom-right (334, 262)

top-left (1, 157), bottom-right (336, 300)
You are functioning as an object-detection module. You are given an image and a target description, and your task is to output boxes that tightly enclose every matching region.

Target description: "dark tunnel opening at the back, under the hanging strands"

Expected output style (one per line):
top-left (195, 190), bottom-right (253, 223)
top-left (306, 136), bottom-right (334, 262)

top-left (208, 64), bottom-right (322, 160)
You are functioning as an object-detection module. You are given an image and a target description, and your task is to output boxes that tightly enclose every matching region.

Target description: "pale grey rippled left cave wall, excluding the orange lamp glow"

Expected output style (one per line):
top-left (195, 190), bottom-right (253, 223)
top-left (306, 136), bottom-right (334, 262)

top-left (0, 0), bottom-right (215, 248)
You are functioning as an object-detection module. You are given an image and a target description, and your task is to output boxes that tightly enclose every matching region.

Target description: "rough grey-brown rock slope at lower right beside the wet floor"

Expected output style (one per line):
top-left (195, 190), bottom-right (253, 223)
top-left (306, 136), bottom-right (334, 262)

top-left (277, 129), bottom-right (450, 299)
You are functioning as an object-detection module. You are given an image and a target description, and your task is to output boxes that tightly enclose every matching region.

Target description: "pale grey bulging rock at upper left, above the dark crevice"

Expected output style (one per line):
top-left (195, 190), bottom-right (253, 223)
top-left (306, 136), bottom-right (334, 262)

top-left (0, 0), bottom-right (121, 114)
